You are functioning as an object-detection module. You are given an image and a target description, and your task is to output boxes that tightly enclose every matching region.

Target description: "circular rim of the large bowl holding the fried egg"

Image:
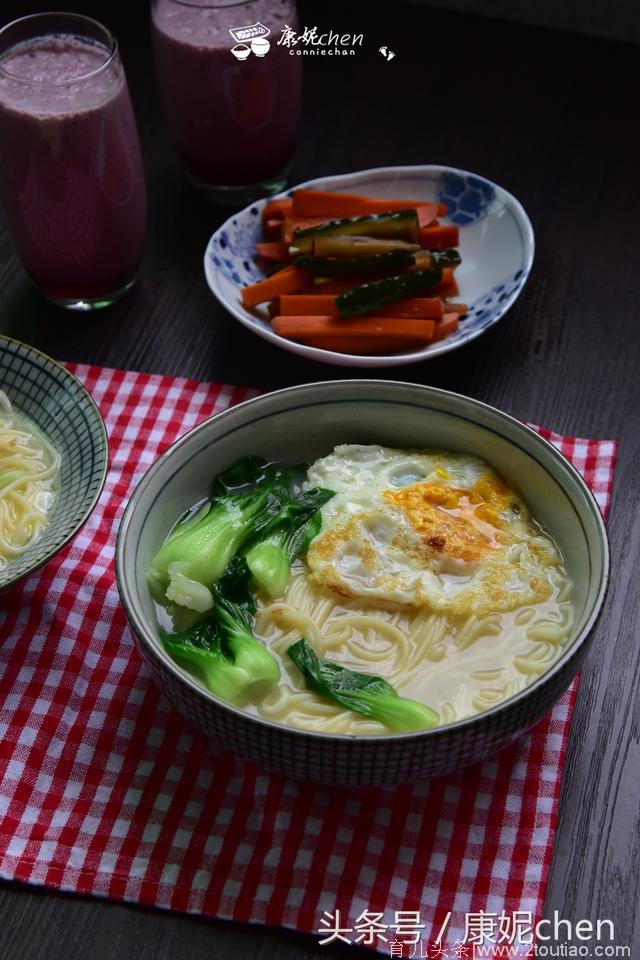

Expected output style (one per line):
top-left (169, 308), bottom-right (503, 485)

top-left (115, 379), bottom-right (610, 742)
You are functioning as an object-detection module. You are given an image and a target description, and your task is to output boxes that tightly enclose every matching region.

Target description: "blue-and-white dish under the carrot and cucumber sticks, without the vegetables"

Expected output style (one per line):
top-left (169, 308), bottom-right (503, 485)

top-left (204, 165), bottom-right (534, 367)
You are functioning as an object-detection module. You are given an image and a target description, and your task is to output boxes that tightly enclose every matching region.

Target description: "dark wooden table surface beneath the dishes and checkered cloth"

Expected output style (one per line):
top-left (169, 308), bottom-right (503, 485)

top-left (0, 0), bottom-right (640, 960)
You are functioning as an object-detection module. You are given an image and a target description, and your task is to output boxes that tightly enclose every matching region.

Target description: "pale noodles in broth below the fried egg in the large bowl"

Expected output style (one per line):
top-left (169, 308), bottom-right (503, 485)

top-left (248, 564), bottom-right (573, 736)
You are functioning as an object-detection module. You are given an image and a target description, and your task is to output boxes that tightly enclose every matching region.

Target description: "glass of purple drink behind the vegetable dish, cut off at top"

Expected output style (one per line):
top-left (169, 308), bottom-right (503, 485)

top-left (152, 0), bottom-right (302, 203)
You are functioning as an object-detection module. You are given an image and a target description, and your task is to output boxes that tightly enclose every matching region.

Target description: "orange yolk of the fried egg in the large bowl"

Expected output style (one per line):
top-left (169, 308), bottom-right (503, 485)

top-left (383, 475), bottom-right (512, 563)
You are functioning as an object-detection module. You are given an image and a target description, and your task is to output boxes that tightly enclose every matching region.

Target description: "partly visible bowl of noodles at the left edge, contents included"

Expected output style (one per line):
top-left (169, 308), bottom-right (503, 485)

top-left (0, 336), bottom-right (108, 590)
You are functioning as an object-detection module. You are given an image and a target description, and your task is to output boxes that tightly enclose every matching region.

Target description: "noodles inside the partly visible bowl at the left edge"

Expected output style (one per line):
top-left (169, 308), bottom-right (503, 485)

top-left (0, 391), bottom-right (60, 571)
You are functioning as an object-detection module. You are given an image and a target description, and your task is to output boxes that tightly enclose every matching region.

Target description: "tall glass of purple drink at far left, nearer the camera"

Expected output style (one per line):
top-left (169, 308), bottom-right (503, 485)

top-left (0, 13), bottom-right (146, 310)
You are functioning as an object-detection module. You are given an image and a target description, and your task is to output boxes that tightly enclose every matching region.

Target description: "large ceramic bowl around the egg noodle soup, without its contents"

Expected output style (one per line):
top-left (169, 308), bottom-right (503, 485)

top-left (116, 380), bottom-right (609, 786)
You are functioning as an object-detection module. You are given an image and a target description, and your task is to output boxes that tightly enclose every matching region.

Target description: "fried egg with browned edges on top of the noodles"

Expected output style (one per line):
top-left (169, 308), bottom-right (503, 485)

top-left (307, 444), bottom-right (562, 616)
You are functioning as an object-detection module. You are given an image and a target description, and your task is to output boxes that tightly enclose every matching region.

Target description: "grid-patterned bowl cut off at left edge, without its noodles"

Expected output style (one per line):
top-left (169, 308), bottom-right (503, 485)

top-left (0, 336), bottom-right (109, 590)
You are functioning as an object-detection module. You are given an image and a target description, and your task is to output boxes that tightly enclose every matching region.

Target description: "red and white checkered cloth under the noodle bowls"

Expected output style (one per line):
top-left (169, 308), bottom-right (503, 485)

top-left (0, 365), bottom-right (616, 955)
